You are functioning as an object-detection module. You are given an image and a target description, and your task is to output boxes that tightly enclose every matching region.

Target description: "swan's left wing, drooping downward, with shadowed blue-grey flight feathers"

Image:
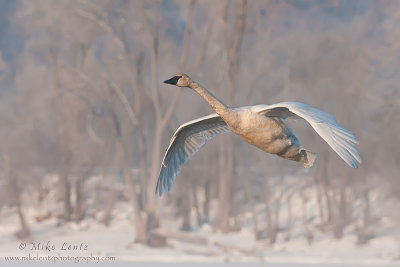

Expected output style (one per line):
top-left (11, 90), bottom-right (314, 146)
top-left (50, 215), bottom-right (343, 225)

top-left (156, 113), bottom-right (230, 196)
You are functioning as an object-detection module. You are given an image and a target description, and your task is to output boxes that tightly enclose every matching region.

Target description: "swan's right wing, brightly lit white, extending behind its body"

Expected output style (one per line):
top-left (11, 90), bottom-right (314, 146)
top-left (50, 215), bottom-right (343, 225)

top-left (257, 102), bottom-right (361, 168)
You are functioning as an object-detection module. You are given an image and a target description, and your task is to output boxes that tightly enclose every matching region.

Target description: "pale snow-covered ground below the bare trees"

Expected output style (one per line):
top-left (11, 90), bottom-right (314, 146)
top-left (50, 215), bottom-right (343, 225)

top-left (0, 204), bottom-right (400, 267)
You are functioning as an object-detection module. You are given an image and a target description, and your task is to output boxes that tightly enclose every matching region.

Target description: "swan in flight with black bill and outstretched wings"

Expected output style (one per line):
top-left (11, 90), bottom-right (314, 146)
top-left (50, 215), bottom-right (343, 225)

top-left (156, 73), bottom-right (361, 196)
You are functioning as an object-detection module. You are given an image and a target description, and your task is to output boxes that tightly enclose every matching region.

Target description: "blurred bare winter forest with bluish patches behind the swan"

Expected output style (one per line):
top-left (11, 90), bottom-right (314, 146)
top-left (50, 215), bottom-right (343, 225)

top-left (0, 0), bottom-right (400, 260)
